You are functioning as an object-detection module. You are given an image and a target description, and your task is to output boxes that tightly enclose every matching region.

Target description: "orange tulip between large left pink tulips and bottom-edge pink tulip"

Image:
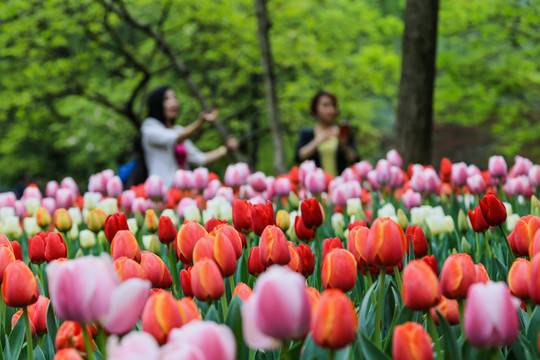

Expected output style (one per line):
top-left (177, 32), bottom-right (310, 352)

top-left (141, 291), bottom-right (183, 345)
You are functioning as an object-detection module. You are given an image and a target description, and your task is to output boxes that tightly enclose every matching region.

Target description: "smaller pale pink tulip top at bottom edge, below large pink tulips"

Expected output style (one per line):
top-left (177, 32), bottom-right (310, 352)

top-left (107, 331), bottom-right (160, 360)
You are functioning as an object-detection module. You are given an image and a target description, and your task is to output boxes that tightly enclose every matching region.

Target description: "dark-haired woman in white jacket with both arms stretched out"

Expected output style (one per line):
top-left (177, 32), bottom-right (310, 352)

top-left (141, 86), bottom-right (238, 188)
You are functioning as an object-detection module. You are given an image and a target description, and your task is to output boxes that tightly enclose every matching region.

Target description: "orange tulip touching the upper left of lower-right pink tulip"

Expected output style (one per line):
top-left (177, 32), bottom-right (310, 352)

top-left (441, 254), bottom-right (476, 299)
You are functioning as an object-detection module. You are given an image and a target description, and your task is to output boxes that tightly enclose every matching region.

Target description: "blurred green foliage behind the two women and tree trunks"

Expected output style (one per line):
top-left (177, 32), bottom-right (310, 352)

top-left (0, 0), bottom-right (540, 191)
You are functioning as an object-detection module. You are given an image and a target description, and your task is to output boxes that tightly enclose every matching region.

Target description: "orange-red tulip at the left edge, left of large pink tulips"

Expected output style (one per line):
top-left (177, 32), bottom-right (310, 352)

top-left (2, 260), bottom-right (39, 307)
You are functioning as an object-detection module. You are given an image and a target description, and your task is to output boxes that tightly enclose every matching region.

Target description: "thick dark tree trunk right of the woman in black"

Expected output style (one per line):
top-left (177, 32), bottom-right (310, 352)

top-left (395, 0), bottom-right (439, 164)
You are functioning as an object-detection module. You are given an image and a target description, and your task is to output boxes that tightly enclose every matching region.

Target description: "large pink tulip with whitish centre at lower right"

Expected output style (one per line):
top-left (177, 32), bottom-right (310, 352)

top-left (464, 281), bottom-right (519, 348)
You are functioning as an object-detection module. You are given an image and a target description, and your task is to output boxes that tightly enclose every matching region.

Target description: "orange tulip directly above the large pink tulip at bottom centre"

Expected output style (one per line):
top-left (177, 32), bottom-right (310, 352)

top-left (259, 225), bottom-right (291, 267)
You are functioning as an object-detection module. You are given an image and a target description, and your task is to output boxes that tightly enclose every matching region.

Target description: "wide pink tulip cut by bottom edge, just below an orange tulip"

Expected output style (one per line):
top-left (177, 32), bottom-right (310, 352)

top-left (168, 321), bottom-right (236, 360)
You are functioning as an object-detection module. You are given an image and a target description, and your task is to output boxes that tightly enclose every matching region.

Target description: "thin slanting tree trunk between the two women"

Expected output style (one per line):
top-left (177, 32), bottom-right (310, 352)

top-left (254, 0), bottom-right (286, 174)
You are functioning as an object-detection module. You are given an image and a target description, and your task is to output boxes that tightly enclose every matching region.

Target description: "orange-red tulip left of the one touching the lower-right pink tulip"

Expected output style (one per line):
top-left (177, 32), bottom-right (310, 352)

top-left (401, 260), bottom-right (441, 311)
